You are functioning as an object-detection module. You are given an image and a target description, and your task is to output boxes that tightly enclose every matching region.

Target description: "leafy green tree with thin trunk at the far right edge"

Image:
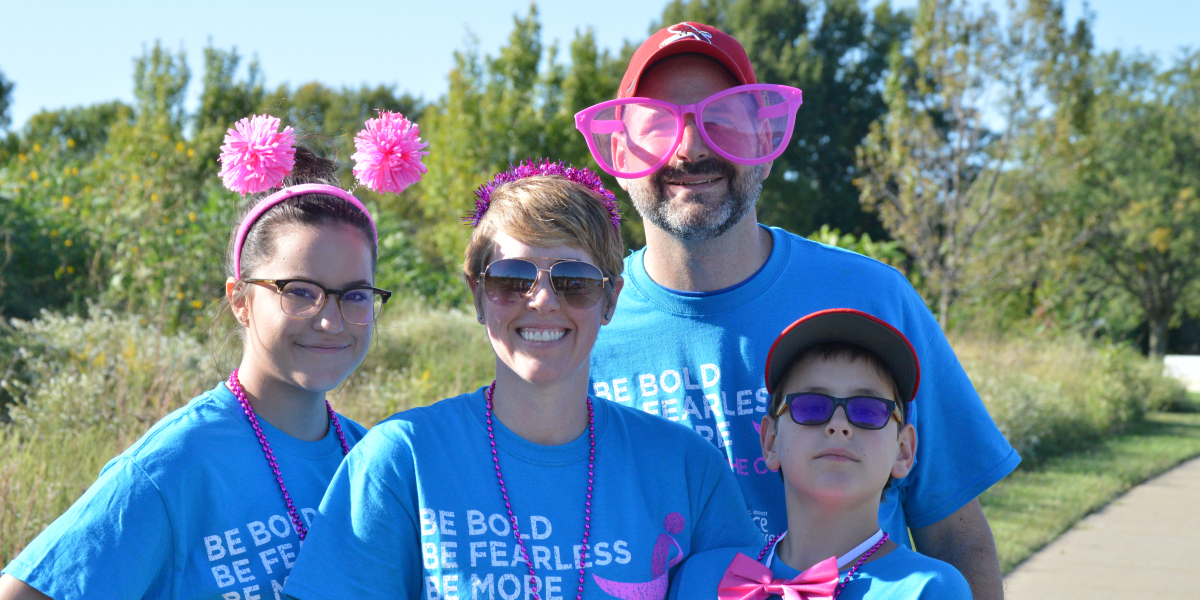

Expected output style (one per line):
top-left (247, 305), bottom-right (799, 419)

top-left (1061, 52), bottom-right (1200, 356)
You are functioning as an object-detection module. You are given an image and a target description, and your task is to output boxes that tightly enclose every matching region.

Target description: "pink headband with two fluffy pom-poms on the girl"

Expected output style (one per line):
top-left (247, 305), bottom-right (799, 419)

top-left (220, 110), bottom-right (428, 280)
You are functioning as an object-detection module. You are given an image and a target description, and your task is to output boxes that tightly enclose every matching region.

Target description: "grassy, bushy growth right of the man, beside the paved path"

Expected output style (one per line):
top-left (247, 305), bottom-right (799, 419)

top-left (952, 336), bottom-right (1186, 467)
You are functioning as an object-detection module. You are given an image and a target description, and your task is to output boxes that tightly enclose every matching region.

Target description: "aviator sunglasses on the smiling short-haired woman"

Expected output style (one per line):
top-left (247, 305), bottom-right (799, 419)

top-left (479, 258), bottom-right (608, 308)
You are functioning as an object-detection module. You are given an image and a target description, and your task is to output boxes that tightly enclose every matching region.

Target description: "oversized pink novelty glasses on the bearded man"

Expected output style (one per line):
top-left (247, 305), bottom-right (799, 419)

top-left (575, 83), bottom-right (804, 179)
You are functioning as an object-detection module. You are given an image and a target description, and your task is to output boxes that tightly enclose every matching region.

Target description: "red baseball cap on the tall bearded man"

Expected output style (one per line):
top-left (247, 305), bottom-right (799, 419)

top-left (617, 22), bottom-right (758, 98)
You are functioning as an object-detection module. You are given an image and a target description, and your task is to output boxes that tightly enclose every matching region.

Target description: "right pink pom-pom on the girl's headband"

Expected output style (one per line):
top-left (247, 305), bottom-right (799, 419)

top-left (350, 110), bottom-right (430, 193)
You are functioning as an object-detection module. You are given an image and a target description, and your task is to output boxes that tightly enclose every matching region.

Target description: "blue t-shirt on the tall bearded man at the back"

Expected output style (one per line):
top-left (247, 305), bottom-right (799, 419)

top-left (592, 228), bottom-right (1020, 545)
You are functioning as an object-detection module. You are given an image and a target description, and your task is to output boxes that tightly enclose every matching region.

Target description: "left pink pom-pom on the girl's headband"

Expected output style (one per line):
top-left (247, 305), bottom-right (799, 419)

top-left (218, 115), bottom-right (296, 196)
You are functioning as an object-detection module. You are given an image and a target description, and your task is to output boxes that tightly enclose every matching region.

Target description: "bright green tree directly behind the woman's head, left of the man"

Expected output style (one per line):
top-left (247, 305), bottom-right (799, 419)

top-left (403, 6), bottom-right (637, 300)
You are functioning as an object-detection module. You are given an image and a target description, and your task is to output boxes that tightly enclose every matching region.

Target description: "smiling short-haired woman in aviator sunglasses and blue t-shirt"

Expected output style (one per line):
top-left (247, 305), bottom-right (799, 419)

top-left (284, 162), bottom-right (761, 600)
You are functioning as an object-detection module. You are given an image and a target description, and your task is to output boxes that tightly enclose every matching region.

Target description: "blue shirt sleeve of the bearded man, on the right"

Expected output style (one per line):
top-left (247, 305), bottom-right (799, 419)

top-left (900, 284), bottom-right (1021, 529)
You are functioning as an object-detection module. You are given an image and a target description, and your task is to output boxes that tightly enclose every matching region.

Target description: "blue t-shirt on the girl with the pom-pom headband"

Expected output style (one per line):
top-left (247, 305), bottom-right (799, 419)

top-left (4, 383), bottom-right (366, 600)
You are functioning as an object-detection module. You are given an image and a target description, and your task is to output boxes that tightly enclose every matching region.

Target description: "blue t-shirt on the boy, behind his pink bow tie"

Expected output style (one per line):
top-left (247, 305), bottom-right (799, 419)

top-left (671, 546), bottom-right (971, 600)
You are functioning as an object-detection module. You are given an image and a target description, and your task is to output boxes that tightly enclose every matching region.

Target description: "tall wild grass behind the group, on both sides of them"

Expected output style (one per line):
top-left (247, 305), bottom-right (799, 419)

top-left (0, 309), bottom-right (1186, 564)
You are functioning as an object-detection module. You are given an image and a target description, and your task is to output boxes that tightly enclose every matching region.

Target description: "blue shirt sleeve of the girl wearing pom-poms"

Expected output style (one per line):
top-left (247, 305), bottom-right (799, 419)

top-left (4, 457), bottom-right (174, 600)
